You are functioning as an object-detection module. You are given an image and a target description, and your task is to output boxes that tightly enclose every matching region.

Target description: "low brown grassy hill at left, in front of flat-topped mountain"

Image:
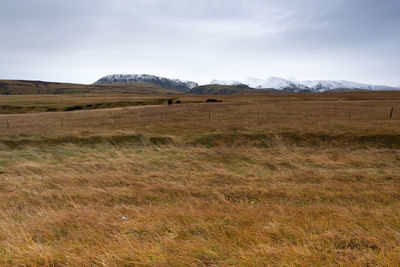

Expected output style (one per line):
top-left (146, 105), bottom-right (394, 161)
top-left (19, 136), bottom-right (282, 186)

top-left (0, 80), bottom-right (179, 95)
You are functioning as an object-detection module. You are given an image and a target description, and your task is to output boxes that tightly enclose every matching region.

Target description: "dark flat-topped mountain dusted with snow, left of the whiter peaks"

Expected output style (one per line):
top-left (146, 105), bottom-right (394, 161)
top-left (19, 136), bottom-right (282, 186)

top-left (95, 74), bottom-right (198, 91)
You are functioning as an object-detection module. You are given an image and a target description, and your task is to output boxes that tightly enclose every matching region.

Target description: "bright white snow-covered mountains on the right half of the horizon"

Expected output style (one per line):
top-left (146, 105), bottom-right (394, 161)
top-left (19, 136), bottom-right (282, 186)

top-left (211, 77), bottom-right (398, 92)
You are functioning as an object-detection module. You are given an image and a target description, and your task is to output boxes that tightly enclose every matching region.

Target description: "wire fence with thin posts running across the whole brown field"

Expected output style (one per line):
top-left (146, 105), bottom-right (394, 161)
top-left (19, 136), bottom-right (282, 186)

top-left (0, 103), bottom-right (400, 132)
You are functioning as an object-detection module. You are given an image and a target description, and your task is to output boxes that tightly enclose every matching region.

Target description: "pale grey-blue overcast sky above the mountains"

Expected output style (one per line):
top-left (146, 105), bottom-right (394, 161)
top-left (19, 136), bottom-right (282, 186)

top-left (0, 0), bottom-right (400, 86)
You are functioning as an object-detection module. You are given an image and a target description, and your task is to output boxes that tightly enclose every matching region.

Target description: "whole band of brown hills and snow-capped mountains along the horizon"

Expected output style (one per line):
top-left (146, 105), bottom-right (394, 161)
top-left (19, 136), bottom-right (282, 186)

top-left (0, 74), bottom-right (400, 95)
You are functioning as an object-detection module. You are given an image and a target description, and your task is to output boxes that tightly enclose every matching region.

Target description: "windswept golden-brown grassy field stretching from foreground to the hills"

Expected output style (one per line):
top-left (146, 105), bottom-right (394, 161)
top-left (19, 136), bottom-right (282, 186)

top-left (0, 92), bottom-right (400, 266)
